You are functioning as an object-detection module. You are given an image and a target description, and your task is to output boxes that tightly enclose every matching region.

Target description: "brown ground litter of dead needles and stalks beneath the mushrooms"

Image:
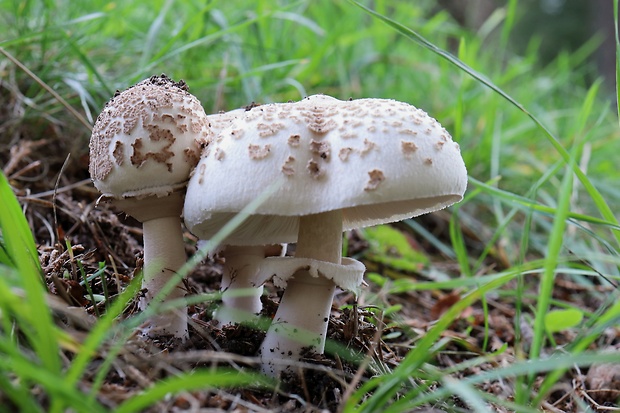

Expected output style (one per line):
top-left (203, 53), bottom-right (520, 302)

top-left (0, 127), bottom-right (620, 412)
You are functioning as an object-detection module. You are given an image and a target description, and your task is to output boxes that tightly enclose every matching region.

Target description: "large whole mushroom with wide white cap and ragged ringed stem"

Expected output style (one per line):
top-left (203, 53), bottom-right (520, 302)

top-left (184, 95), bottom-right (467, 375)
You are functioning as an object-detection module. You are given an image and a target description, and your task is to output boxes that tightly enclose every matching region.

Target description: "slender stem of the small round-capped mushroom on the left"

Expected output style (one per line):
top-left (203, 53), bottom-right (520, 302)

top-left (114, 192), bottom-right (188, 339)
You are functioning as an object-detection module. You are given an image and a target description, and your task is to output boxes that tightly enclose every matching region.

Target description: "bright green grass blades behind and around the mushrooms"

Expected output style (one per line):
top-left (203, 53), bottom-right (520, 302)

top-left (0, 0), bottom-right (620, 412)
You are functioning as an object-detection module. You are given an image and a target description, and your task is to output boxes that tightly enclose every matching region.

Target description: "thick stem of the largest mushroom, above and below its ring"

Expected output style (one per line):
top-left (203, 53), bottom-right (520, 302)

top-left (259, 210), bottom-right (342, 376)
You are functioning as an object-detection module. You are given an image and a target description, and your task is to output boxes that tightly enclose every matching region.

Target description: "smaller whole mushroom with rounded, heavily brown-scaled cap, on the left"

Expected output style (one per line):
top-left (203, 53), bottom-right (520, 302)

top-left (89, 75), bottom-right (211, 338)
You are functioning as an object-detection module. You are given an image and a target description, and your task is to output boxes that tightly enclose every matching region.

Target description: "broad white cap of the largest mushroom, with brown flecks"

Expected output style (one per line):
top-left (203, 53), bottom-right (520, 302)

top-left (184, 95), bottom-right (467, 245)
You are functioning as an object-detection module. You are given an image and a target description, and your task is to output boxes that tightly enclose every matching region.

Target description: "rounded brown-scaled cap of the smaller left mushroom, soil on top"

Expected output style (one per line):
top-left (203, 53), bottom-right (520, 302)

top-left (89, 75), bottom-right (211, 198)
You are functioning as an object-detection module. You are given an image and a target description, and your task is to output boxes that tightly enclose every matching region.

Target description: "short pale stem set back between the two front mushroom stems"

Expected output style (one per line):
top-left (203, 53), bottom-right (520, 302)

top-left (215, 245), bottom-right (265, 325)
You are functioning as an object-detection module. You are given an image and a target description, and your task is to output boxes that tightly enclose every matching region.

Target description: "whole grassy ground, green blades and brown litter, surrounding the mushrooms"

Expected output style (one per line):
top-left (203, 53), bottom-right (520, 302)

top-left (0, 0), bottom-right (620, 412)
